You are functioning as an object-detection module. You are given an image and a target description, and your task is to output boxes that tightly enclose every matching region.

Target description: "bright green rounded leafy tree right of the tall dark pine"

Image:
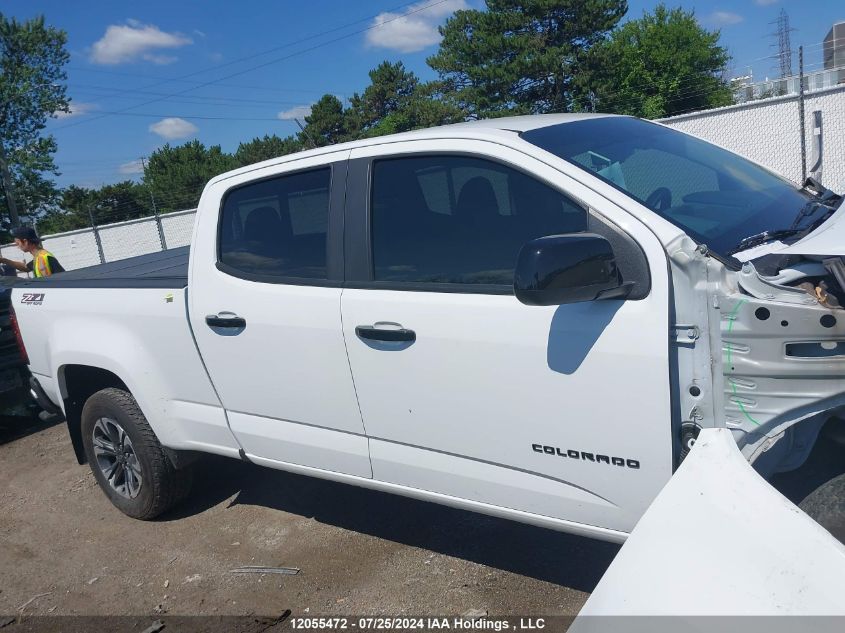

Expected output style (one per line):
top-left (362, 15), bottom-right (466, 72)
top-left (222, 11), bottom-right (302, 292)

top-left (587, 4), bottom-right (733, 119)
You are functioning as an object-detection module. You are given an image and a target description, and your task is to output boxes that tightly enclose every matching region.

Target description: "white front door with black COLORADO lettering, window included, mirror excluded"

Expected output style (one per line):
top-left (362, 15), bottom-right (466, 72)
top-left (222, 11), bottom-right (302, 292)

top-left (342, 140), bottom-right (672, 531)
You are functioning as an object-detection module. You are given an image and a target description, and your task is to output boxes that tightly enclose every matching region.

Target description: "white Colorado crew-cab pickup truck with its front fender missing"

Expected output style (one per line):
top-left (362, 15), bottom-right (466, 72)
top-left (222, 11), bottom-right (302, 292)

top-left (8, 115), bottom-right (845, 556)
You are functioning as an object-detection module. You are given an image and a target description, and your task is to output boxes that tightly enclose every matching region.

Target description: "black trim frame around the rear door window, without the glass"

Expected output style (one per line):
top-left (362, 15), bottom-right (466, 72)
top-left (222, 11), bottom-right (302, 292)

top-left (215, 159), bottom-right (349, 288)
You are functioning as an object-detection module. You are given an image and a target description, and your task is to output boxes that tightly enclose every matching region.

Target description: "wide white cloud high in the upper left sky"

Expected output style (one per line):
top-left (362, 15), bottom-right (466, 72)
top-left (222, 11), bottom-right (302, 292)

top-left (90, 20), bottom-right (193, 66)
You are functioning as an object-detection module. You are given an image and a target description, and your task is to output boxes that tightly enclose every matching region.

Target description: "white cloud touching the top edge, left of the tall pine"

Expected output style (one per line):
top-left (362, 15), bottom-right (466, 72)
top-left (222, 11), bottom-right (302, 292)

top-left (366, 0), bottom-right (467, 53)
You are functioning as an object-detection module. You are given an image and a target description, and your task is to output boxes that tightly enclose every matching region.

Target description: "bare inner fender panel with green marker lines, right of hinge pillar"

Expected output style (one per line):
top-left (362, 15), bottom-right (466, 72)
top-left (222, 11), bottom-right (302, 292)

top-left (719, 254), bottom-right (845, 476)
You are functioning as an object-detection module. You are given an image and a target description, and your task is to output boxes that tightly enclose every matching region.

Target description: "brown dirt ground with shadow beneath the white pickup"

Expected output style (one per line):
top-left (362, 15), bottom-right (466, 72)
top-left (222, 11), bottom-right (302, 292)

top-left (0, 414), bottom-right (618, 617)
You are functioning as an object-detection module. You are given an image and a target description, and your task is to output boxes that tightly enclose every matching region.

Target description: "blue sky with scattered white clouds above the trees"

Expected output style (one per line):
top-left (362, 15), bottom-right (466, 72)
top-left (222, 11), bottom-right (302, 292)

top-left (0, 0), bottom-right (845, 187)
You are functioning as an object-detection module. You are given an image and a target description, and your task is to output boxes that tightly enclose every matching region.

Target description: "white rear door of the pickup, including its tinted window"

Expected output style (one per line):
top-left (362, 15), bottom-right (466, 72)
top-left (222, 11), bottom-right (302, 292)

top-left (189, 151), bottom-right (372, 477)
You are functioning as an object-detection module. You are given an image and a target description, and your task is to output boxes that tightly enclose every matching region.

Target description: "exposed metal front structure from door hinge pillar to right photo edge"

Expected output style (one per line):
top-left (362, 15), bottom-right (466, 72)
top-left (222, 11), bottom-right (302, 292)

top-left (668, 237), bottom-right (845, 477)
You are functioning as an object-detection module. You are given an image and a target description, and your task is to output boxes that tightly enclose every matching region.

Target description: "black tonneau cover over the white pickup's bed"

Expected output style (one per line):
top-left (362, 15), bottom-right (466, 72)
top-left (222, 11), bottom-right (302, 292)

top-left (17, 246), bottom-right (190, 288)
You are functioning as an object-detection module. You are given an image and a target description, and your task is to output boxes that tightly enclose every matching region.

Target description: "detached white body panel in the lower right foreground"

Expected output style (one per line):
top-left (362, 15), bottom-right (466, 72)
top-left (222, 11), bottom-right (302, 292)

top-left (570, 429), bottom-right (845, 620)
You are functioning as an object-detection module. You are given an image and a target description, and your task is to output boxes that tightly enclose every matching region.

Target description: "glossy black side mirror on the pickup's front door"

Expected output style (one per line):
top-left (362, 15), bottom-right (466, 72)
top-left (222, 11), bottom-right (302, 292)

top-left (513, 233), bottom-right (634, 306)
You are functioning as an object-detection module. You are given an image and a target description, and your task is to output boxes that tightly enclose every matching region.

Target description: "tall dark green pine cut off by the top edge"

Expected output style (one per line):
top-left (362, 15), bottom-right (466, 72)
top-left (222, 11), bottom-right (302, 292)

top-left (428, 0), bottom-right (628, 117)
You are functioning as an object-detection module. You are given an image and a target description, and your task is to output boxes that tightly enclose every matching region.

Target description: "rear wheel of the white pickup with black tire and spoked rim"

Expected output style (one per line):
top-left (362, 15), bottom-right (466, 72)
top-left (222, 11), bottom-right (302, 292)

top-left (81, 388), bottom-right (193, 520)
